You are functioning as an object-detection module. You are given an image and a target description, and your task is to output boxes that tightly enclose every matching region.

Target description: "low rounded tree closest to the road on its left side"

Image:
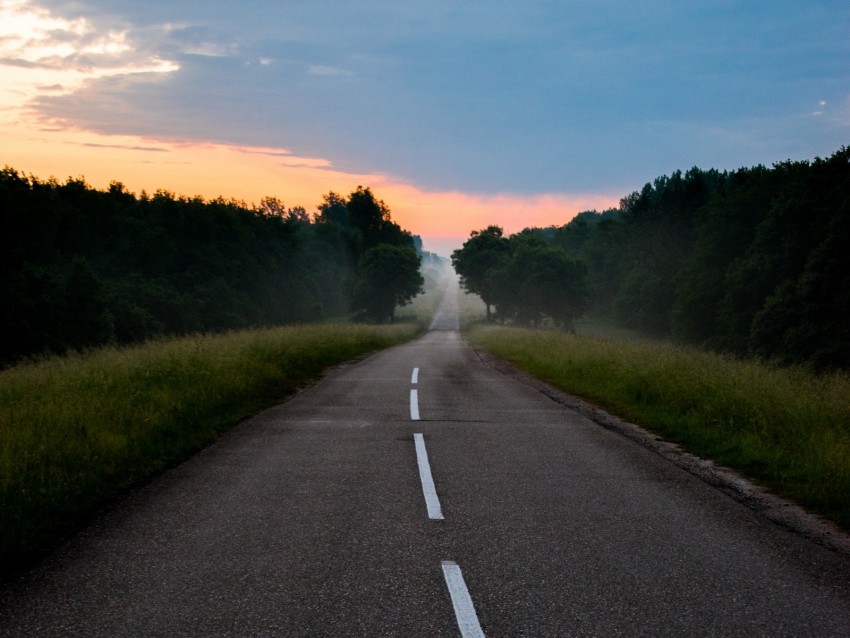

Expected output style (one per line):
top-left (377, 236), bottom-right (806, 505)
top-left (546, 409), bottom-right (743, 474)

top-left (354, 244), bottom-right (425, 323)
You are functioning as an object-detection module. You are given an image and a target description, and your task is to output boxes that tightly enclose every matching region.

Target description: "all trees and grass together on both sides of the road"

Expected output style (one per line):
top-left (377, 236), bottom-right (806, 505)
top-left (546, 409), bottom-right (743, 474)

top-left (0, 148), bottom-right (850, 570)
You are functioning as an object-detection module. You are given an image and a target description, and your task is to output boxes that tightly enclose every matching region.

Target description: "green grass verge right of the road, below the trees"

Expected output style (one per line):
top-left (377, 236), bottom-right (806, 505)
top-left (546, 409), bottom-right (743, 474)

top-left (469, 326), bottom-right (850, 529)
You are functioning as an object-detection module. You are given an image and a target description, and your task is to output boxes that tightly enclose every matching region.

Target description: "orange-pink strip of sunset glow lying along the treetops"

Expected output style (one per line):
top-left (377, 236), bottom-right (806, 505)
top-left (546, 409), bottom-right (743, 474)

top-left (0, 121), bottom-right (618, 256)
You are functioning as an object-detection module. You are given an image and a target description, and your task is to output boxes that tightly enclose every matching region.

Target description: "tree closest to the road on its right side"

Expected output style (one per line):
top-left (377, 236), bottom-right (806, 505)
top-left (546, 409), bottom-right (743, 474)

top-left (452, 226), bottom-right (511, 321)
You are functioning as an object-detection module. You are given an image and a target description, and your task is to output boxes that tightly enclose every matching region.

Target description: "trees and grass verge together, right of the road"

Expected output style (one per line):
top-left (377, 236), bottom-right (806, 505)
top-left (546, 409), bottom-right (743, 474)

top-left (452, 147), bottom-right (850, 529)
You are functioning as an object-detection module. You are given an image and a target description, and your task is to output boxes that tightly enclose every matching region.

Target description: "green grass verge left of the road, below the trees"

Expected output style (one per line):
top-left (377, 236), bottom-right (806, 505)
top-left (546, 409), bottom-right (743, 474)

top-left (0, 324), bottom-right (420, 574)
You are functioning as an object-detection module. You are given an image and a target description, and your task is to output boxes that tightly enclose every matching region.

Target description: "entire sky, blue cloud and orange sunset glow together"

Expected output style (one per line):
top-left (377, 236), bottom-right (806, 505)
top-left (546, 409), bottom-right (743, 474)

top-left (0, 0), bottom-right (850, 255)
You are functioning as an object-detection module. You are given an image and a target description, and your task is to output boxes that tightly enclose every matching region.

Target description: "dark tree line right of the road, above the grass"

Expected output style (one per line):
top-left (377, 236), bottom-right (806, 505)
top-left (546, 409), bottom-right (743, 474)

top-left (452, 147), bottom-right (850, 369)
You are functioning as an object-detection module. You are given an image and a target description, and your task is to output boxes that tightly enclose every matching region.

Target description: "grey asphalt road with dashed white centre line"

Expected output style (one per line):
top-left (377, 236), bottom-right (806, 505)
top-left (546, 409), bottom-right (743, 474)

top-left (0, 282), bottom-right (850, 637)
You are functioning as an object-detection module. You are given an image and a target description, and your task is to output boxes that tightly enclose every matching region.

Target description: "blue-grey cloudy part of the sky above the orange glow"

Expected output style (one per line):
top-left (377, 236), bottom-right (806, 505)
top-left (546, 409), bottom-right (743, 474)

top-left (2, 0), bottom-right (850, 250)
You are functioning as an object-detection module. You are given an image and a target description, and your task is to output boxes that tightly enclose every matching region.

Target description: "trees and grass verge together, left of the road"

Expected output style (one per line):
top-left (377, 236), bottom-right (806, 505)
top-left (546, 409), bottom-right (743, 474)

top-left (0, 168), bottom-right (438, 574)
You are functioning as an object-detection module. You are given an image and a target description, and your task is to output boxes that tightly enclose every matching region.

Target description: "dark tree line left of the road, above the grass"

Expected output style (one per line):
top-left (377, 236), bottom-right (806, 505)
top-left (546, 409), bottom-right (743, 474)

top-left (0, 167), bottom-right (423, 364)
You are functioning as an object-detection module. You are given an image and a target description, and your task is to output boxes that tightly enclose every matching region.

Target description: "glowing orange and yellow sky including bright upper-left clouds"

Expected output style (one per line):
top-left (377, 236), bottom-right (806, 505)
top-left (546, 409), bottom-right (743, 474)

top-left (0, 0), bottom-right (622, 255)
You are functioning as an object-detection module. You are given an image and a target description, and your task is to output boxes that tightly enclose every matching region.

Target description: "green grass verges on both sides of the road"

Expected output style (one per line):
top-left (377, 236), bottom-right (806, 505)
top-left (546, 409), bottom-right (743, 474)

top-left (8, 271), bottom-right (850, 575)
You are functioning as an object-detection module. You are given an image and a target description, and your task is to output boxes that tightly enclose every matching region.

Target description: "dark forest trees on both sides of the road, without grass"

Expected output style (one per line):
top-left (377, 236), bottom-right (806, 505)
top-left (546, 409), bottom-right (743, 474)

top-left (6, 147), bottom-right (850, 370)
